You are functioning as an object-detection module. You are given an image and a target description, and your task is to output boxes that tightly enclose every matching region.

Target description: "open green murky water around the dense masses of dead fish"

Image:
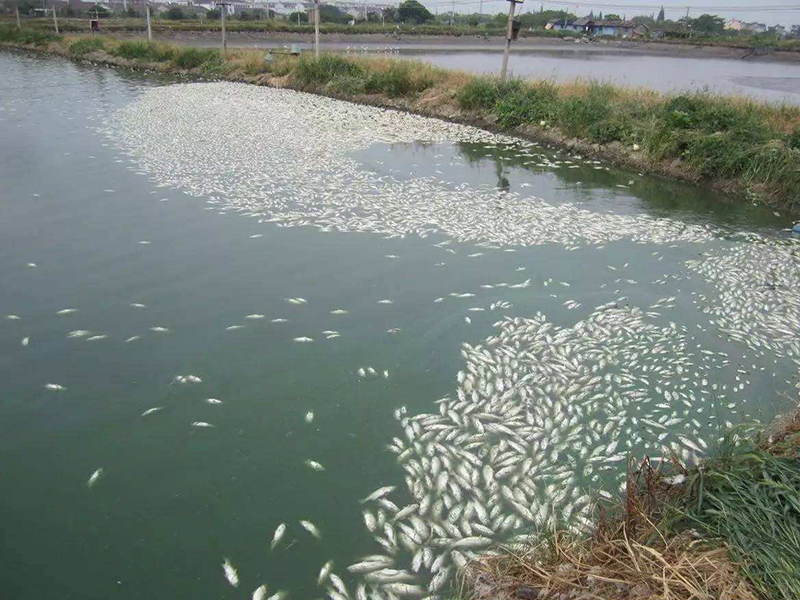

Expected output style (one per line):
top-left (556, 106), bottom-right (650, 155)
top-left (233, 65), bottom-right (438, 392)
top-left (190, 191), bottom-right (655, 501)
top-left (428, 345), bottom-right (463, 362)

top-left (0, 54), bottom-right (797, 599)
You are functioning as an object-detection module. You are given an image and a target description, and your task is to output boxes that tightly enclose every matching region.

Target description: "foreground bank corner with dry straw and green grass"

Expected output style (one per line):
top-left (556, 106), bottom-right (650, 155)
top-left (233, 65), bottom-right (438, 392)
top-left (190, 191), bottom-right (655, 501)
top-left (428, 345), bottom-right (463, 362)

top-left (462, 409), bottom-right (800, 600)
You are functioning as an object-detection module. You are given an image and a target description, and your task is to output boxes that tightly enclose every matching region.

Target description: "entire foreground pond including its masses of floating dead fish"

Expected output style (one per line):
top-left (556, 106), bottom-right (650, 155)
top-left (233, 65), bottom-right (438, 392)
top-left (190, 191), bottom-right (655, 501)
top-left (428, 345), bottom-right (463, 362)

top-left (0, 53), bottom-right (800, 600)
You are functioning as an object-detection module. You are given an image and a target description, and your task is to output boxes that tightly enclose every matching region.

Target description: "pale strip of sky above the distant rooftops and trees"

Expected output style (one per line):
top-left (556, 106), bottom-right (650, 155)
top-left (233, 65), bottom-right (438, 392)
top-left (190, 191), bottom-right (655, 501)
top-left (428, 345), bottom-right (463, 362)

top-left (421, 0), bottom-right (800, 26)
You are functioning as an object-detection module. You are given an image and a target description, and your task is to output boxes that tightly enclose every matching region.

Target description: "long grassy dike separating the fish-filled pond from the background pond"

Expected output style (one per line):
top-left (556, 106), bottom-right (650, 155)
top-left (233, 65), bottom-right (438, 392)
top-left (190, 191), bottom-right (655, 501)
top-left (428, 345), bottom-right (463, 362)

top-left (0, 27), bottom-right (800, 212)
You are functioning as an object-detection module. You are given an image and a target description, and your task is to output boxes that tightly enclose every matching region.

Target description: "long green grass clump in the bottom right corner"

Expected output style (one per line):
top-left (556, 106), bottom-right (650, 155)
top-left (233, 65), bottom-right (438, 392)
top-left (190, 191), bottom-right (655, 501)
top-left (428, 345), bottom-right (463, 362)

top-left (687, 436), bottom-right (800, 600)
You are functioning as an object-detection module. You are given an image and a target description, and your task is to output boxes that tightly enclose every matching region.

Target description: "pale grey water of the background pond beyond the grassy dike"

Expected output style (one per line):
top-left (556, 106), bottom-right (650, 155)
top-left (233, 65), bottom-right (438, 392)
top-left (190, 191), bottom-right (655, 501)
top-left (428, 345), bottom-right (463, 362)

top-left (167, 33), bottom-right (800, 104)
